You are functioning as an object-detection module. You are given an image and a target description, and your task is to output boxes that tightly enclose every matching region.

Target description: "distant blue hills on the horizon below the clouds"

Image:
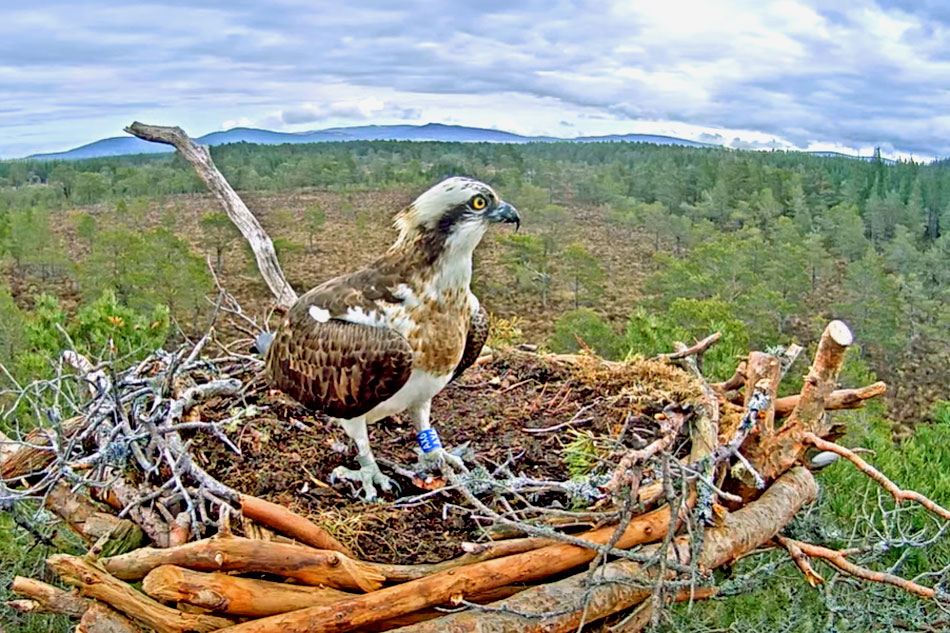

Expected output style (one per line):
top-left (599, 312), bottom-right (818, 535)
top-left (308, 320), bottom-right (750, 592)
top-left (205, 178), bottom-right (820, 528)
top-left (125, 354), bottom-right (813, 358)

top-left (28, 123), bottom-right (713, 160)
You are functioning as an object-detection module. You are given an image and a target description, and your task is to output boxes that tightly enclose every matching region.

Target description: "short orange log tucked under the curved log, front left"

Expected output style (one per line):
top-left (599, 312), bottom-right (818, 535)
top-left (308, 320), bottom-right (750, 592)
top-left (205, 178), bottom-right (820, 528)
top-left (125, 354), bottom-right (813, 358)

top-left (142, 565), bottom-right (353, 618)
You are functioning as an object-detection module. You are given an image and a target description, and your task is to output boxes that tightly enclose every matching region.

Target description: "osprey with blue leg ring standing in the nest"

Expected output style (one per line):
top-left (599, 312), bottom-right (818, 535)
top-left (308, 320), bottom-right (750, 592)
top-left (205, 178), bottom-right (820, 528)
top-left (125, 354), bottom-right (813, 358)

top-left (258, 178), bottom-right (521, 501)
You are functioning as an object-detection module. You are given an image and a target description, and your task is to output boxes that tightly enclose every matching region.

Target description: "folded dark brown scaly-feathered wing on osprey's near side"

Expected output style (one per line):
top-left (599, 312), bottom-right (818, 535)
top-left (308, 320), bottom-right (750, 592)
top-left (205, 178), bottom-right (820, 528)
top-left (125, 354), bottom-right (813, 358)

top-left (265, 291), bottom-right (413, 419)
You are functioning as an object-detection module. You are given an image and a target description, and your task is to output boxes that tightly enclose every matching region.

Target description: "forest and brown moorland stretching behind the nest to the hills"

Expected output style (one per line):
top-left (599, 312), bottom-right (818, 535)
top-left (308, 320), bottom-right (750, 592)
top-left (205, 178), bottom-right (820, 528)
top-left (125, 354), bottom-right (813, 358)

top-left (0, 142), bottom-right (950, 632)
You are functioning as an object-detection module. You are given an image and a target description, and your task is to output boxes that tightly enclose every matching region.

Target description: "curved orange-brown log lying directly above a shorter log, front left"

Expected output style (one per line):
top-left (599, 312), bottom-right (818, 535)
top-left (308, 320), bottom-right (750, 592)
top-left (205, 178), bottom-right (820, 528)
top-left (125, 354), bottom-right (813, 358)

top-left (102, 536), bottom-right (385, 591)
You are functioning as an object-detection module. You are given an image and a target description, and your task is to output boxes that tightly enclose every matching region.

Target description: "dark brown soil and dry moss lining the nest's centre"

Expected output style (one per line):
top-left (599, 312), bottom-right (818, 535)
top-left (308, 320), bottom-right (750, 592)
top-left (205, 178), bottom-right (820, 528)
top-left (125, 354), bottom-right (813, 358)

top-left (195, 350), bottom-right (702, 564)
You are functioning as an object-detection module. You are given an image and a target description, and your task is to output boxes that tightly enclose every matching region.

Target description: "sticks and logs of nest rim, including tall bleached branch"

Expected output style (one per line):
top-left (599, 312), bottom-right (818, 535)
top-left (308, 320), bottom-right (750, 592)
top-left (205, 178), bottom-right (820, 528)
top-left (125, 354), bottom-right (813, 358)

top-left (0, 124), bottom-right (950, 633)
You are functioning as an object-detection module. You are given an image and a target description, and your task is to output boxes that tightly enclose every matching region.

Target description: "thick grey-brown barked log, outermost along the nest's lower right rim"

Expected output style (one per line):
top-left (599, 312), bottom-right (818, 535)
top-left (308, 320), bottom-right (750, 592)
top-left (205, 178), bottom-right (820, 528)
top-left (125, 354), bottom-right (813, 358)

top-left (386, 467), bottom-right (818, 633)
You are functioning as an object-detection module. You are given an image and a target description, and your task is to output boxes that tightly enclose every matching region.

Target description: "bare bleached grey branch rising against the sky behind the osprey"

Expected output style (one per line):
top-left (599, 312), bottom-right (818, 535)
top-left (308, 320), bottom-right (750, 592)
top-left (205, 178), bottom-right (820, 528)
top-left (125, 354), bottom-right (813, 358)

top-left (125, 121), bottom-right (297, 308)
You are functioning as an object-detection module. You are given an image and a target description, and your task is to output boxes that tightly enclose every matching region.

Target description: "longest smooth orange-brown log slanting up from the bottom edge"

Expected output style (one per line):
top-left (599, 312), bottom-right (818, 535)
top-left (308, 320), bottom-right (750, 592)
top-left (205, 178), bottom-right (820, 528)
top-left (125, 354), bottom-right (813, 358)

top-left (212, 498), bottom-right (670, 633)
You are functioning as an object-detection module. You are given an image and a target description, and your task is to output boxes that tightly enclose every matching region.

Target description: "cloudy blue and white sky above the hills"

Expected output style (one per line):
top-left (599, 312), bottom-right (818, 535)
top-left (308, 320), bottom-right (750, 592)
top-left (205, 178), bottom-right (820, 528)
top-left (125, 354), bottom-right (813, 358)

top-left (0, 0), bottom-right (950, 159)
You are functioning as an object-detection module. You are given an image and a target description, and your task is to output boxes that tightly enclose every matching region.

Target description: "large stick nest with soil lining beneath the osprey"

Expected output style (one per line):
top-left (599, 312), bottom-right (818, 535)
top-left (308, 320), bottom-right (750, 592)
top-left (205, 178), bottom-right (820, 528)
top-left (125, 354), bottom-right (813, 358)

top-left (0, 324), bottom-right (892, 633)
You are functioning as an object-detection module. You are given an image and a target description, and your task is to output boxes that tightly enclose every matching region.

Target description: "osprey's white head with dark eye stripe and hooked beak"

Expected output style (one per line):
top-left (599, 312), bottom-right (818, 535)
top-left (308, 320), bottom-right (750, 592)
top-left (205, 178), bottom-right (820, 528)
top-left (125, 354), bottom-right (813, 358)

top-left (396, 178), bottom-right (521, 262)
